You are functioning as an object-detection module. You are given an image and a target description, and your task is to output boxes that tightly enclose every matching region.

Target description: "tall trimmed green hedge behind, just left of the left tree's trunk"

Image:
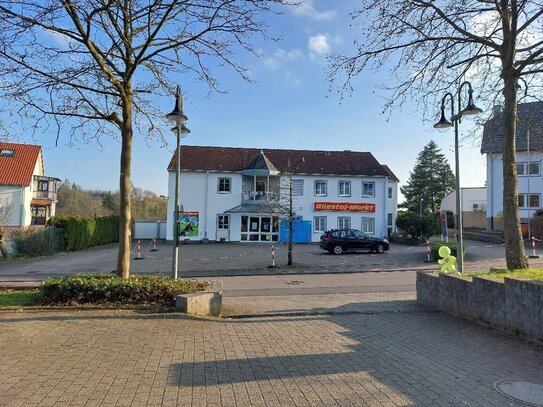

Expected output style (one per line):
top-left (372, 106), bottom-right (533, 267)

top-left (49, 216), bottom-right (119, 251)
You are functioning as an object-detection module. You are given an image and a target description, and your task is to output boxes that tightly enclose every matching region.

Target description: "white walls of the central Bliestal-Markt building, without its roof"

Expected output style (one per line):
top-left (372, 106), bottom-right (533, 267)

top-left (167, 170), bottom-right (398, 242)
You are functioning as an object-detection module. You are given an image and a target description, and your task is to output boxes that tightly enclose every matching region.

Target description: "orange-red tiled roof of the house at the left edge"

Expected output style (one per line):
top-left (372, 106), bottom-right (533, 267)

top-left (0, 143), bottom-right (43, 186)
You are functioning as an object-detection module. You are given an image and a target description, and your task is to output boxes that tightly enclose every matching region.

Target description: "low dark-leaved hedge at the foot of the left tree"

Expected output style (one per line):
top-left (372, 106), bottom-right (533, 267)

top-left (40, 274), bottom-right (207, 305)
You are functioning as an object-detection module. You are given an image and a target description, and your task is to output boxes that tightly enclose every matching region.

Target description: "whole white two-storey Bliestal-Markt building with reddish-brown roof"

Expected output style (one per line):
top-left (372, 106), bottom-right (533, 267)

top-left (167, 146), bottom-right (398, 242)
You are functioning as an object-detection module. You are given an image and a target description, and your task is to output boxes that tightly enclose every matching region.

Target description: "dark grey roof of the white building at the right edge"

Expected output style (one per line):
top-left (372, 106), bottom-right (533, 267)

top-left (481, 102), bottom-right (543, 154)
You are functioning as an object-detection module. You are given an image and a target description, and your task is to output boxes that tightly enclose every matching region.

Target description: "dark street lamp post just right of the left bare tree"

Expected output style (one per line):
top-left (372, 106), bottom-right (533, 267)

top-left (166, 86), bottom-right (190, 279)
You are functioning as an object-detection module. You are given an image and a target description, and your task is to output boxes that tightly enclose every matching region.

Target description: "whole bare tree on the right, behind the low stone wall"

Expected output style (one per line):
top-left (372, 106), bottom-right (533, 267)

top-left (331, 0), bottom-right (543, 269)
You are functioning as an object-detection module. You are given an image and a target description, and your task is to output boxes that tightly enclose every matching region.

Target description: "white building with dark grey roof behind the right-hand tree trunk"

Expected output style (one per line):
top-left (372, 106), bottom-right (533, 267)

top-left (481, 102), bottom-right (543, 230)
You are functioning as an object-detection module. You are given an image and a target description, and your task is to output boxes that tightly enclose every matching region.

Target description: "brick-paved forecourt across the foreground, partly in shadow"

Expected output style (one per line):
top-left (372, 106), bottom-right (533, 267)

top-left (0, 298), bottom-right (543, 407)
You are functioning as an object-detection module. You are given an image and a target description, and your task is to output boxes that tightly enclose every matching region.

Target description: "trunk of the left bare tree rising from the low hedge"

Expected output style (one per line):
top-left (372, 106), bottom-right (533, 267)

top-left (117, 95), bottom-right (132, 279)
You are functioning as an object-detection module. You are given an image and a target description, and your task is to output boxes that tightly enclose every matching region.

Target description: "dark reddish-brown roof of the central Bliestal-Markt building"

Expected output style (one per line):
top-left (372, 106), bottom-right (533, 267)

top-left (168, 146), bottom-right (398, 177)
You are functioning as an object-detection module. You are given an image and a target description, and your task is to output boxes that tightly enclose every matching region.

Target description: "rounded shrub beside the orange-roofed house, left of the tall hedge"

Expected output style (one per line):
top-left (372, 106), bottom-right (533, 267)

top-left (11, 226), bottom-right (64, 257)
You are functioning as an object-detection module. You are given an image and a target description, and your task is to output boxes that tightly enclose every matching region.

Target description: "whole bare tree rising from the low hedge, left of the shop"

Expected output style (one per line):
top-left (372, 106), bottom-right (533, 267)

top-left (0, 0), bottom-right (285, 278)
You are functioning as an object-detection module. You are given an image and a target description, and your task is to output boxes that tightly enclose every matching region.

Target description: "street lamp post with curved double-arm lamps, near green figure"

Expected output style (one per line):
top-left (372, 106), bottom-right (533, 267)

top-left (434, 81), bottom-right (483, 273)
